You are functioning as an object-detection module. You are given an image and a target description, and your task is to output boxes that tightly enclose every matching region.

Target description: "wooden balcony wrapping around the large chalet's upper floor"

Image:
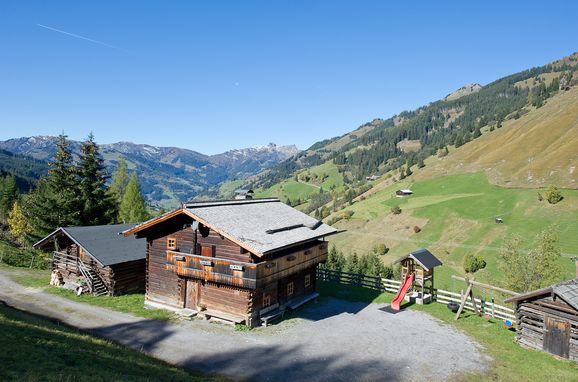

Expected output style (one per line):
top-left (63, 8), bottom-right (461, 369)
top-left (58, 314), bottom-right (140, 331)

top-left (167, 242), bottom-right (327, 289)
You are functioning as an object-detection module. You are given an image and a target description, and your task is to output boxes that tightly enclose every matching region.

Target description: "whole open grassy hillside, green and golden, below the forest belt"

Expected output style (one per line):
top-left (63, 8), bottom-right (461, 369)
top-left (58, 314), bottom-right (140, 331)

top-left (330, 88), bottom-right (578, 289)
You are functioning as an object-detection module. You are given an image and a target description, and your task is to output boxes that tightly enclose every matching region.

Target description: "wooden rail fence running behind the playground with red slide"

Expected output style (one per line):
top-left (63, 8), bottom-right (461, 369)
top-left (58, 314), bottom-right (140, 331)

top-left (317, 267), bottom-right (516, 321)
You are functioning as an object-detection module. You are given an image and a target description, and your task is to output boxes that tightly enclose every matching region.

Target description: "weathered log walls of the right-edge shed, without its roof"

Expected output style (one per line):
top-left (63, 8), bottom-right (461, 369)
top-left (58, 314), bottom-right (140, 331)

top-left (516, 297), bottom-right (578, 361)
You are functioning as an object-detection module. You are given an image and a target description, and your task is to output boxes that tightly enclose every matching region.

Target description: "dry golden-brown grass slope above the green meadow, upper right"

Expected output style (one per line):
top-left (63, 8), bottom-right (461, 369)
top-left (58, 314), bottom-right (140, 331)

top-left (414, 87), bottom-right (578, 188)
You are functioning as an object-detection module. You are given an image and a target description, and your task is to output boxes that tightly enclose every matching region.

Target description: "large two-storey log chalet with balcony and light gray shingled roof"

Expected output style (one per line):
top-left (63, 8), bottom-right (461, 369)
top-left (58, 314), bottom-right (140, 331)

top-left (125, 199), bottom-right (337, 326)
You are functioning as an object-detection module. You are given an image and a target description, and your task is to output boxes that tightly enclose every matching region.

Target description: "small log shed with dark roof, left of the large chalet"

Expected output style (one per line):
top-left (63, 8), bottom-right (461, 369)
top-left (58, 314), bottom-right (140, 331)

top-left (34, 224), bottom-right (146, 296)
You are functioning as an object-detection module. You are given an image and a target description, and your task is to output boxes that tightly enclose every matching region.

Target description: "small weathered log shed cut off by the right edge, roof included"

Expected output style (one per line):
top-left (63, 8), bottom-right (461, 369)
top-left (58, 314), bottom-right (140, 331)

top-left (505, 278), bottom-right (578, 361)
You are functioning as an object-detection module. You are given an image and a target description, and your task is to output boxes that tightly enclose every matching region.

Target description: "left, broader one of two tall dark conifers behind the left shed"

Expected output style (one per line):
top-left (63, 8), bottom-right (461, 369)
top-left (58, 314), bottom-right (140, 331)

top-left (25, 135), bottom-right (81, 238)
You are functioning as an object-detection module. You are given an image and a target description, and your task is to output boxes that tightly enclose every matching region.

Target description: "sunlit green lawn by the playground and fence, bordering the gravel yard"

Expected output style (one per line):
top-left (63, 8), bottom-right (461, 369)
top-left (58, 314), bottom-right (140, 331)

top-left (317, 282), bottom-right (578, 382)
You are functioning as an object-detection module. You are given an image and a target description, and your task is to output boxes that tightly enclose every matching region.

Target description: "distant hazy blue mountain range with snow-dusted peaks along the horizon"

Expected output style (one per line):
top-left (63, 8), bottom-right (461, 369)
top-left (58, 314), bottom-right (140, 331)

top-left (0, 136), bottom-right (298, 207)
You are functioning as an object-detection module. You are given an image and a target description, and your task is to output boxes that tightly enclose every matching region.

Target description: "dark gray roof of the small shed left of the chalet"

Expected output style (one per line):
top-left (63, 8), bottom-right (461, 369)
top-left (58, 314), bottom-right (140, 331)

top-left (34, 224), bottom-right (146, 266)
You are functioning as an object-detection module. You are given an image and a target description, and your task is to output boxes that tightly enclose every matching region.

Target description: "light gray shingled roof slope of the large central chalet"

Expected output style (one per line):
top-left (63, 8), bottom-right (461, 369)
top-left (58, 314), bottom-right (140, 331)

top-left (184, 199), bottom-right (337, 254)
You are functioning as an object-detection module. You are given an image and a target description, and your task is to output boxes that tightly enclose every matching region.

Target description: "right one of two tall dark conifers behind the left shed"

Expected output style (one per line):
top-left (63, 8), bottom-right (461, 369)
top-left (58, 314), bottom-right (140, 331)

top-left (77, 133), bottom-right (116, 225)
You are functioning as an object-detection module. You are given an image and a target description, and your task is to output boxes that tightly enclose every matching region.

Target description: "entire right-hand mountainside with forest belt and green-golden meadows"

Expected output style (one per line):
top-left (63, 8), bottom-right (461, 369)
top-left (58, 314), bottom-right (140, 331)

top-left (220, 53), bottom-right (578, 290)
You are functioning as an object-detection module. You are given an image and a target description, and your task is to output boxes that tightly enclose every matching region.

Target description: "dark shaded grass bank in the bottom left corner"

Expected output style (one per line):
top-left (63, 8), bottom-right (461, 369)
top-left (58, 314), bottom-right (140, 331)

top-left (0, 304), bottom-right (225, 381)
